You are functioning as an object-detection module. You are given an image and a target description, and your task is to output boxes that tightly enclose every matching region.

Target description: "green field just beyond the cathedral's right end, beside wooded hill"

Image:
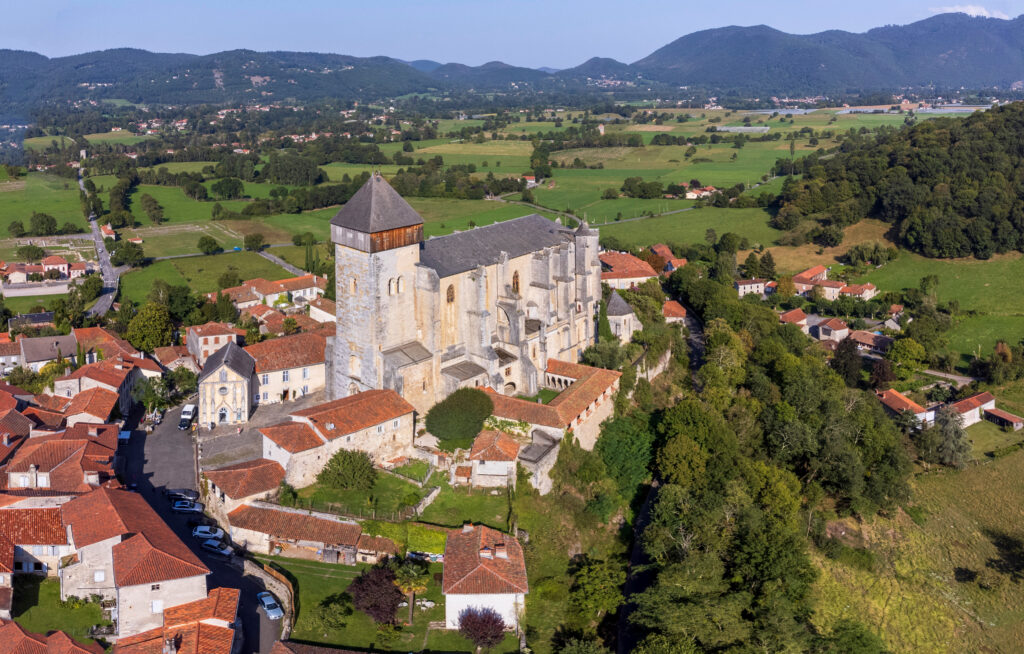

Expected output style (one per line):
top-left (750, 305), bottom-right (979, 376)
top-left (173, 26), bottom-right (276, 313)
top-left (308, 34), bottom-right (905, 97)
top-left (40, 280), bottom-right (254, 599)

top-left (600, 207), bottom-right (780, 252)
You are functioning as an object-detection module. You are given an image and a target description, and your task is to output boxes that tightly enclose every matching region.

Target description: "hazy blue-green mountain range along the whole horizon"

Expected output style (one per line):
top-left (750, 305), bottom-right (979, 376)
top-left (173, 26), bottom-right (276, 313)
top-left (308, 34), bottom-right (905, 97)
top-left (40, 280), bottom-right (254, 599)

top-left (0, 13), bottom-right (1024, 116)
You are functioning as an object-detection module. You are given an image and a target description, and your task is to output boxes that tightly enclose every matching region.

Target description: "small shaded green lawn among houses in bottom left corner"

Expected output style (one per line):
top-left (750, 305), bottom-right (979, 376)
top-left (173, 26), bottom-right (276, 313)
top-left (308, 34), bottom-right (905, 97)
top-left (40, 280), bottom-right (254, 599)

top-left (11, 574), bottom-right (103, 644)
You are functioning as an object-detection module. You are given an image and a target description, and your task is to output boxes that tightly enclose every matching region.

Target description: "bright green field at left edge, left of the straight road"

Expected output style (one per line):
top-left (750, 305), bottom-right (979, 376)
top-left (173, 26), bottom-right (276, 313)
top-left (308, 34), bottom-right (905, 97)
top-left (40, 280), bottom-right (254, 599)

top-left (0, 173), bottom-right (88, 233)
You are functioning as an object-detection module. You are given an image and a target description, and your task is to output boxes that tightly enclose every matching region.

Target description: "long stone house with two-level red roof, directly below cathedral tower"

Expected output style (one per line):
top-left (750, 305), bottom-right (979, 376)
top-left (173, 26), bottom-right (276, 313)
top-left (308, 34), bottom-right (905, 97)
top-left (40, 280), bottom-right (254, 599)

top-left (259, 390), bottom-right (416, 487)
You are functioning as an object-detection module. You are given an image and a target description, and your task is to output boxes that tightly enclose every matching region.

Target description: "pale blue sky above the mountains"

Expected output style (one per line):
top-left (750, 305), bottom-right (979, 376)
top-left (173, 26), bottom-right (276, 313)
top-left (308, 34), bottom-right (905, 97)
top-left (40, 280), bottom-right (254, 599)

top-left (6, 0), bottom-right (1024, 68)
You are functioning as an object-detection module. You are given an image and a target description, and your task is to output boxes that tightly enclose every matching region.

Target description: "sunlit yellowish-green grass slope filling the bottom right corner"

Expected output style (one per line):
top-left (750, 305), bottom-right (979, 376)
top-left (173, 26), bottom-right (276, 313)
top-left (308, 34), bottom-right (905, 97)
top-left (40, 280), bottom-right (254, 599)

top-left (814, 451), bottom-right (1024, 652)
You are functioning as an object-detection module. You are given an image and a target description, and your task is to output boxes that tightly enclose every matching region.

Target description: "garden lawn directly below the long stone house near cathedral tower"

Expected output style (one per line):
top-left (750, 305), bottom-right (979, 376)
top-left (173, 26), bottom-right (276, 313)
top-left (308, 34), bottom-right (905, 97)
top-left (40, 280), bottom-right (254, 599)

top-left (299, 473), bottom-right (423, 524)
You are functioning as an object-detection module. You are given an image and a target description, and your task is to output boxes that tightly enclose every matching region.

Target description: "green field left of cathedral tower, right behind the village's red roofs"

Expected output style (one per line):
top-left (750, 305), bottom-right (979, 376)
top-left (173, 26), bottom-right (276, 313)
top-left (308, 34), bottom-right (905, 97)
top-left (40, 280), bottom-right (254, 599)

top-left (121, 251), bottom-right (292, 303)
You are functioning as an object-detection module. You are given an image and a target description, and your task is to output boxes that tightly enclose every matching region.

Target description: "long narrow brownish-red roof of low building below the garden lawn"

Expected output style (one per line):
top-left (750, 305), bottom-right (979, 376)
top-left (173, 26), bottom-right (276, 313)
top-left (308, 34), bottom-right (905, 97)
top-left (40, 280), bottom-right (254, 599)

top-left (227, 505), bottom-right (362, 547)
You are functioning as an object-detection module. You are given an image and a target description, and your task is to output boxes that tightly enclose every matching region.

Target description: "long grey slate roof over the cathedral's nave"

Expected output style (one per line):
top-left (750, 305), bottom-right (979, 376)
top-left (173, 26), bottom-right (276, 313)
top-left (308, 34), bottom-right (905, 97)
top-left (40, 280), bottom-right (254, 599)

top-left (420, 214), bottom-right (572, 277)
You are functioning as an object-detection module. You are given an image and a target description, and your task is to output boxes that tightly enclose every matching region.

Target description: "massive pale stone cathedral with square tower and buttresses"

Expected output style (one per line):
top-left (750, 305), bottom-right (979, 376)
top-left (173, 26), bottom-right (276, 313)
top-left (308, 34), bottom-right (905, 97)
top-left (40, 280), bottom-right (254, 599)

top-left (331, 174), bottom-right (601, 413)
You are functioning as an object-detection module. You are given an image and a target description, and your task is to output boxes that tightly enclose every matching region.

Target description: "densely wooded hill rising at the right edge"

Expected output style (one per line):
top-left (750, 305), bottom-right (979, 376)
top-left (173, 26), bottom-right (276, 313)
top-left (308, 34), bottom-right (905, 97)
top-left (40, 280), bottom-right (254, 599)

top-left (773, 102), bottom-right (1024, 259)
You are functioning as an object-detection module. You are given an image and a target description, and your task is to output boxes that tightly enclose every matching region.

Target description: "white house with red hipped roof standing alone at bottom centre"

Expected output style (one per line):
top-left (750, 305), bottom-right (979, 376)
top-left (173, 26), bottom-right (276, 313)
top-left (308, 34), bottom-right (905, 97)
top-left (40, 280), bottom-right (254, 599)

top-left (441, 524), bottom-right (529, 629)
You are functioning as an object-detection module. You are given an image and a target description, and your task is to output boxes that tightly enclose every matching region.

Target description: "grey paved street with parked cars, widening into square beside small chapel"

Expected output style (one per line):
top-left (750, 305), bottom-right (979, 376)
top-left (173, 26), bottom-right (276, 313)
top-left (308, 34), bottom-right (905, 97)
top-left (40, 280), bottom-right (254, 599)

top-left (119, 408), bottom-right (281, 654)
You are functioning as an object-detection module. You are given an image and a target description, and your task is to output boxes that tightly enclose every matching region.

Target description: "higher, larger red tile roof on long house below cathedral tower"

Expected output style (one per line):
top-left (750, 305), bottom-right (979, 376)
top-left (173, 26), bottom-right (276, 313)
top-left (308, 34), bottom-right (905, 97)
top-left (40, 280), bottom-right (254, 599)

top-left (292, 390), bottom-right (416, 440)
